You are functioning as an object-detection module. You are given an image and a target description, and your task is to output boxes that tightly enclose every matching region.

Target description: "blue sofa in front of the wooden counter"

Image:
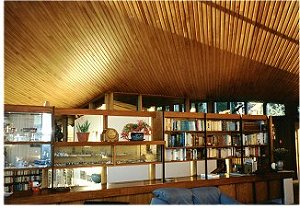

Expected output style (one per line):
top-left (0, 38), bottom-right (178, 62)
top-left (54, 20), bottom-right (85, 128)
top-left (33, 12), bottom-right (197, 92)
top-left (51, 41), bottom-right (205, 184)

top-left (150, 187), bottom-right (240, 204)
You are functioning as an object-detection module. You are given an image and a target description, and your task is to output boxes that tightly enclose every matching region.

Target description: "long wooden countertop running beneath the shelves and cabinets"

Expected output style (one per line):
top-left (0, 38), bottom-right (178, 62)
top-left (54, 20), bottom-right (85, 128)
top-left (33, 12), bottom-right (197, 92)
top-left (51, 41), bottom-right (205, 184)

top-left (4, 171), bottom-right (294, 204)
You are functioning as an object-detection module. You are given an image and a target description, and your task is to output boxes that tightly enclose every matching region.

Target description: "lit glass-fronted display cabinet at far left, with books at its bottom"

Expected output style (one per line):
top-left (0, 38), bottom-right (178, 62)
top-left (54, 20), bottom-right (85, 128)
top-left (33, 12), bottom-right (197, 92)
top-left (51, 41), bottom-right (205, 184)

top-left (3, 105), bottom-right (53, 193)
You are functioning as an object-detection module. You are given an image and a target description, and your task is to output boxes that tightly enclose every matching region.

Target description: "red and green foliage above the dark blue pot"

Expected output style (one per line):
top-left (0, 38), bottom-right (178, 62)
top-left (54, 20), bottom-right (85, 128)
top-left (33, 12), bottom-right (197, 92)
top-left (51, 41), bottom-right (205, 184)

top-left (121, 120), bottom-right (151, 139)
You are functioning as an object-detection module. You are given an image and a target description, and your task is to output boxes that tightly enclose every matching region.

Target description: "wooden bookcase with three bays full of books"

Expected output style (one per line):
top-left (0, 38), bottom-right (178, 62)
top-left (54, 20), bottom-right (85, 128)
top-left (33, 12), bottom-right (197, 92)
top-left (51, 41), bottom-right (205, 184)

top-left (164, 112), bottom-right (269, 178)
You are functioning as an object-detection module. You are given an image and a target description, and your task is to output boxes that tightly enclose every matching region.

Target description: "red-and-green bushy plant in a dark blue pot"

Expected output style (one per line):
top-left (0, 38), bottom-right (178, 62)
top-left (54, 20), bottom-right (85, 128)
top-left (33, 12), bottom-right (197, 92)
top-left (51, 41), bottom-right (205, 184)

top-left (121, 120), bottom-right (151, 141)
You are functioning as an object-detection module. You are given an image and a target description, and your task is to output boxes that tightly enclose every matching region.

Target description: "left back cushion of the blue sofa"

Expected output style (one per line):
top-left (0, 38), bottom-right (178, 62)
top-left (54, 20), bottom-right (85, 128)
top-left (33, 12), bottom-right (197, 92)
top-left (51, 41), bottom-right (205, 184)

top-left (152, 188), bottom-right (193, 204)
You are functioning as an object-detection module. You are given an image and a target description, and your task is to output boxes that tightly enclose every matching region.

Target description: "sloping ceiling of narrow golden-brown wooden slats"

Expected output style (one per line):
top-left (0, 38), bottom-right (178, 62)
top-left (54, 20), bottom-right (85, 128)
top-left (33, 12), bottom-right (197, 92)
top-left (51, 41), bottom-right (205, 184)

top-left (4, 1), bottom-right (299, 107)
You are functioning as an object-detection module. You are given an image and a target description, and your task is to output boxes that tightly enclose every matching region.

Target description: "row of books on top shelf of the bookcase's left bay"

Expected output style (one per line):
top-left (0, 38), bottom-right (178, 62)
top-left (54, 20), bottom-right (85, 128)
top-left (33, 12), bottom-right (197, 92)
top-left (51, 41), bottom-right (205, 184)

top-left (165, 118), bottom-right (205, 131)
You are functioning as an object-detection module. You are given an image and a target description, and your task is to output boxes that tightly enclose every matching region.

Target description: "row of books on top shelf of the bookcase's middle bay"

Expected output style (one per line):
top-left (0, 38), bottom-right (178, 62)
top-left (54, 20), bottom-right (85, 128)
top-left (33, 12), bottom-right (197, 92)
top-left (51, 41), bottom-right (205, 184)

top-left (206, 120), bottom-right (240, 131)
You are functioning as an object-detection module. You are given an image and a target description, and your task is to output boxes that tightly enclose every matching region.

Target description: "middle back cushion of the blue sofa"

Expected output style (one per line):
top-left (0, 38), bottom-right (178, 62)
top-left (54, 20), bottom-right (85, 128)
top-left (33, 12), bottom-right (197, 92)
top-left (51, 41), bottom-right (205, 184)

top-left (192, 187), bottom-right (221, 204)
